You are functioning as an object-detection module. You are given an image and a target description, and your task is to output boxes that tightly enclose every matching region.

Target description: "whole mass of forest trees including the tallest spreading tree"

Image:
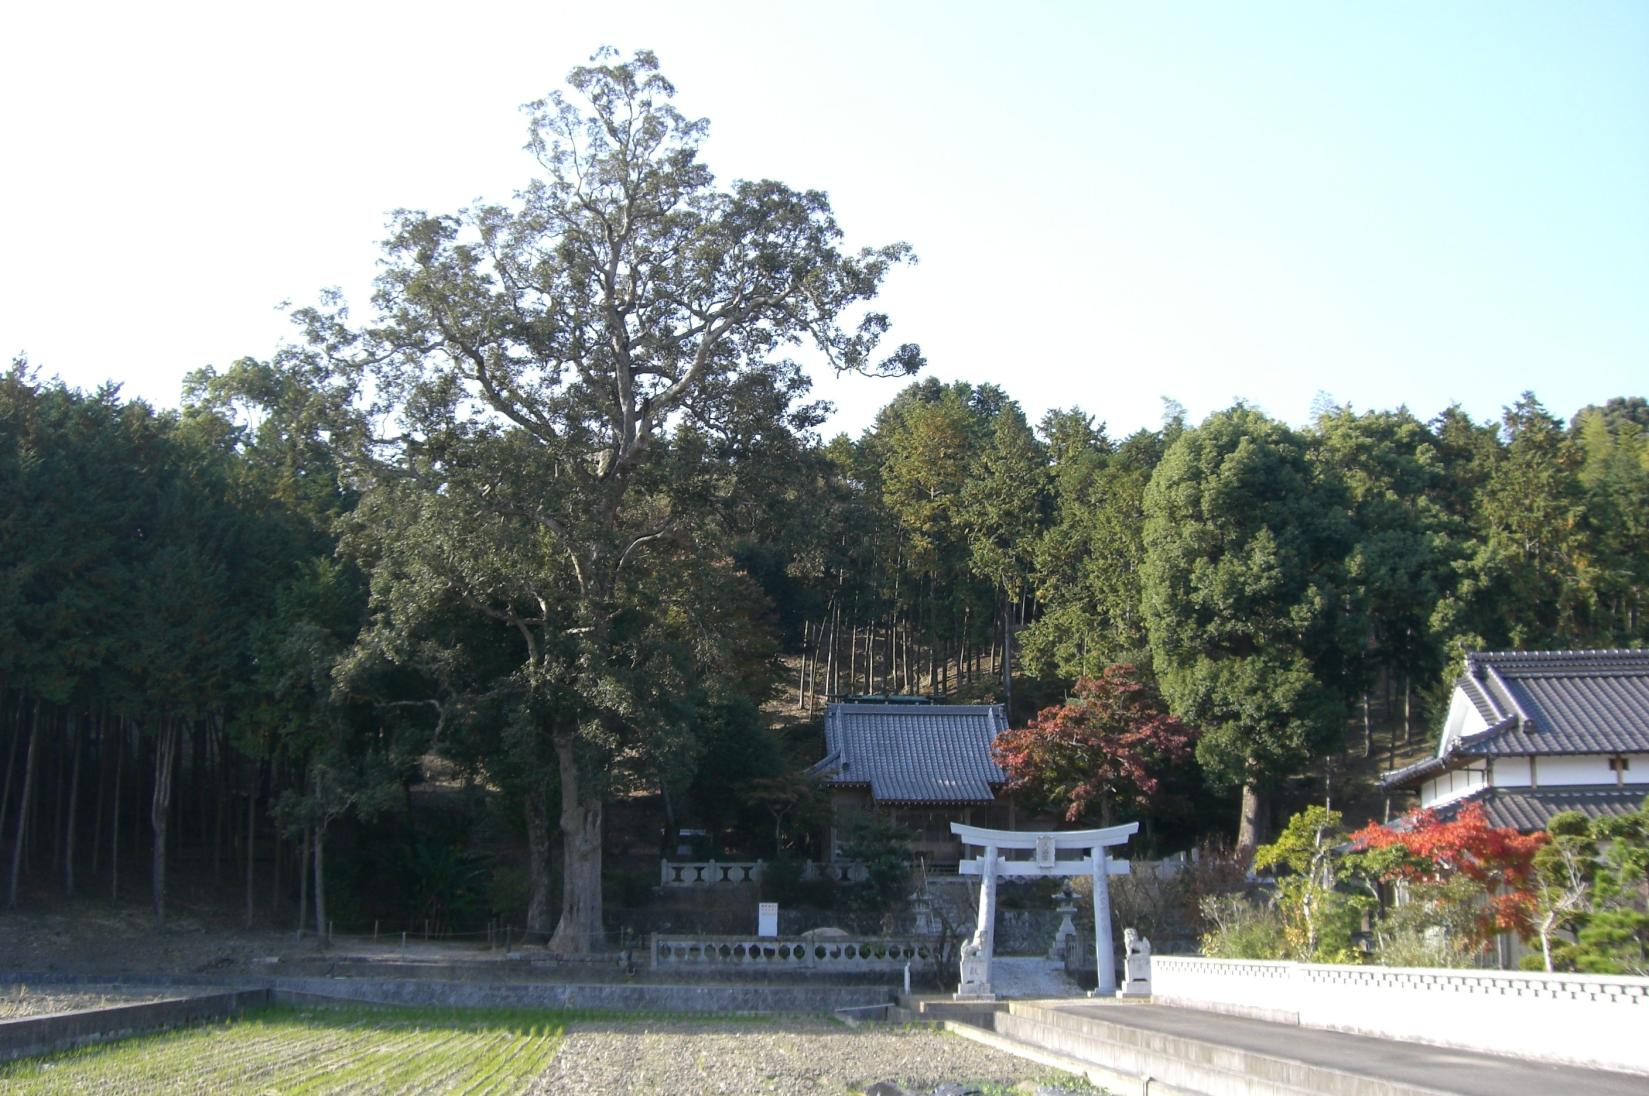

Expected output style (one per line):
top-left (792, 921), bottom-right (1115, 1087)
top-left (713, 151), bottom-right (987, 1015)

top-left (0, 53), bottom-right (1649, 953)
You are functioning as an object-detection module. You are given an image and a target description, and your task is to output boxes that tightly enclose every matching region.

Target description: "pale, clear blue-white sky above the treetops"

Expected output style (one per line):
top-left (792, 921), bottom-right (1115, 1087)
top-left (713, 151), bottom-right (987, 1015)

top-left (0, 0), bottom-right (1649, 433)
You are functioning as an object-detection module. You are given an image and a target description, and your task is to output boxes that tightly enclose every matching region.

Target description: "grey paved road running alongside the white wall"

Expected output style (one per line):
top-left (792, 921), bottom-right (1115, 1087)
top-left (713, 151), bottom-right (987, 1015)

top-left (1041, 1000), bottom-right (1649, 1096)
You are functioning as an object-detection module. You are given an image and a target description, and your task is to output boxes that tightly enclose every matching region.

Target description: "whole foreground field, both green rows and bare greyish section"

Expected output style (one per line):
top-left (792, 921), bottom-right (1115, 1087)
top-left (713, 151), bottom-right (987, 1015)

top-left (0, 1005), bottom-right (1095, 1096)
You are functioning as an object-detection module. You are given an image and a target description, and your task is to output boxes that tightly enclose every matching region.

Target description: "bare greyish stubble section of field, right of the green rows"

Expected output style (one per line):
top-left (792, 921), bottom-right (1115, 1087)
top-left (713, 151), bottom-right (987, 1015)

top-left (531, 1017), bottom-right (1095, 1096)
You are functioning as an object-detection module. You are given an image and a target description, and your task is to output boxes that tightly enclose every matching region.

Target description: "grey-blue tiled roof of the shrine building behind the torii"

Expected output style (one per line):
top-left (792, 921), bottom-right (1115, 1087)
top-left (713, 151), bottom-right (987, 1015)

top-left (813, 704), bottom-right (1008, 803)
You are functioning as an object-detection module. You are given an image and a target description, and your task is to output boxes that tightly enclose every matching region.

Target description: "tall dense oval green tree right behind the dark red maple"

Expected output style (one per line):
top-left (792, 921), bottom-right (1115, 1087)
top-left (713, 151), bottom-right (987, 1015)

top-left (1141, 407), bottom-right (1364, 852)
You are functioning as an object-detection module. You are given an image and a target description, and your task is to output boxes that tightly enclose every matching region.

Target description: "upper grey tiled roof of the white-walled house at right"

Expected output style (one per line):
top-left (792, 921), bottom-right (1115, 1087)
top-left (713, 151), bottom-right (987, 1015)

top-left (1458, 651), bottom-right (1649, 756)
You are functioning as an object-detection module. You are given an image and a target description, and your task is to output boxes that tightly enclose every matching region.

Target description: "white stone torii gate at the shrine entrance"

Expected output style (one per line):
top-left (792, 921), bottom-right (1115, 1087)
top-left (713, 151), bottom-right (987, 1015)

top-left (950, 822), bottom-right (1139, 1000)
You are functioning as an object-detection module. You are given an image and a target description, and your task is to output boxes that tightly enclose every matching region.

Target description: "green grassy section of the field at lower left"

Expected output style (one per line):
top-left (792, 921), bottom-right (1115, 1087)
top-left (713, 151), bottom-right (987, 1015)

top-left (0, 1005), bottom-right (590, 1096)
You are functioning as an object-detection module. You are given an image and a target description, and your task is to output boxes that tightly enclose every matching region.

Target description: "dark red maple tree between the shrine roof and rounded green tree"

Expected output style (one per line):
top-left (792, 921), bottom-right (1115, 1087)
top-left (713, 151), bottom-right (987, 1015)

top-left (993, 664), bottom-right (1196, 824)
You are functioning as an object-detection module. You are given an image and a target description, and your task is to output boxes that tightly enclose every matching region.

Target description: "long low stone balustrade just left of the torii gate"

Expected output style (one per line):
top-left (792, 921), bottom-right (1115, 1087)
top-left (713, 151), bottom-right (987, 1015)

top-left (651, 933), bottom-right (935, 974)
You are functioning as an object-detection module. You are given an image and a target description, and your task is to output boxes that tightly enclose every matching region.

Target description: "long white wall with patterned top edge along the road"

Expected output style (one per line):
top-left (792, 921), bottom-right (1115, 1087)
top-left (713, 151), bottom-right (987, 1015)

top-left (1151, 956), bottom-right (1649, 1073)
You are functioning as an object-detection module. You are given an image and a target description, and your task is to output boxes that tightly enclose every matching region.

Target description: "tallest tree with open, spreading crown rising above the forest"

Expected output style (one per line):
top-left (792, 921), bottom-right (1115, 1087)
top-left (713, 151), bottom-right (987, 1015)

top-left (305, 51), bottom-right (922, 953)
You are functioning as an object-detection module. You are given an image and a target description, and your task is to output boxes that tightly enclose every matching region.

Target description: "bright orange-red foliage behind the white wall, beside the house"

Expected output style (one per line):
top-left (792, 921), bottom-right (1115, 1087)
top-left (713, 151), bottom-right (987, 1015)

top-left (1351, 803), bottom-right (1547, 936)
